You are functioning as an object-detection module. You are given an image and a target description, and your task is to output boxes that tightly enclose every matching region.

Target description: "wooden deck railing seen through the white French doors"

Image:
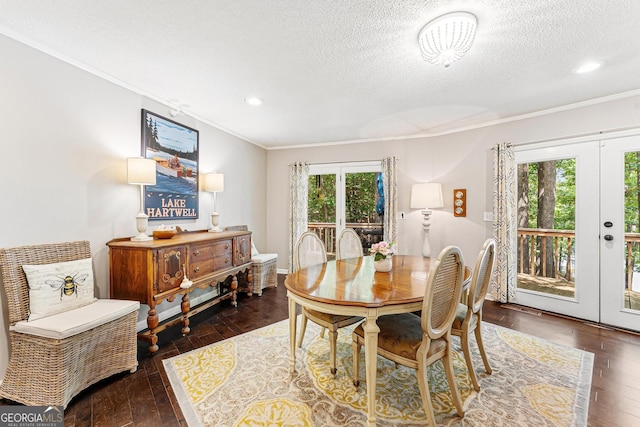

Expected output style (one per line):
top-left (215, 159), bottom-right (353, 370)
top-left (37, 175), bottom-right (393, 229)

top-left (518, 228), bottom-right (640, 289)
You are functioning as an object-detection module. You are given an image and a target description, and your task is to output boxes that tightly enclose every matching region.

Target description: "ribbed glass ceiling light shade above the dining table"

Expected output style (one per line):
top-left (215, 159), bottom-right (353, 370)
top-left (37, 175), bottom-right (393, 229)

top-left (418, 12), bottom-right (478, 67)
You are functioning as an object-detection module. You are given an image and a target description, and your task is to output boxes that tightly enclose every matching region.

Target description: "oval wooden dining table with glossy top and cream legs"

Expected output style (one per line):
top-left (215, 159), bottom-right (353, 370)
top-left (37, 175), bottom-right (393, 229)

top-left (284, 255), bottom-right (471, 426)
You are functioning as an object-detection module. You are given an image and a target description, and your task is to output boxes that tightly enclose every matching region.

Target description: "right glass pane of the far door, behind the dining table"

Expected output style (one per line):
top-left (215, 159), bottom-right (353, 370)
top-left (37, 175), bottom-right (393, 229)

top-left (345, 172), bottom-right (384, 255)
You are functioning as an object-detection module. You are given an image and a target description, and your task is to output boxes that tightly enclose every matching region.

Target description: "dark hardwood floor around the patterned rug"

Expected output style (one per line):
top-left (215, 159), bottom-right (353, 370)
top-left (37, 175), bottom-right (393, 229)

top-left (0, 276), bottom-right (640, 427)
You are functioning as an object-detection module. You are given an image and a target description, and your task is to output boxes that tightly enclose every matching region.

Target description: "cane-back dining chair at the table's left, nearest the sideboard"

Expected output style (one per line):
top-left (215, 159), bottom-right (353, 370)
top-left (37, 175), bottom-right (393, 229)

top-left (294, 231), bottom-right (362, 375)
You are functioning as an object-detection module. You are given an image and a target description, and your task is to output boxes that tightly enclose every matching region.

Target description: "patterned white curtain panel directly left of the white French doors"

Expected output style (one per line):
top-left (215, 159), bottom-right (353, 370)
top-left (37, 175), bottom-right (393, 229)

top-left (490, 142), bottom-right (518, 302)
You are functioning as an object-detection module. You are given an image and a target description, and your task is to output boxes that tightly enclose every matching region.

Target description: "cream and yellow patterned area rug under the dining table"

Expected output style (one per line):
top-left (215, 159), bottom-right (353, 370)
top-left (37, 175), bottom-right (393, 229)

top-left (164, 321), bottom-right (593, 427)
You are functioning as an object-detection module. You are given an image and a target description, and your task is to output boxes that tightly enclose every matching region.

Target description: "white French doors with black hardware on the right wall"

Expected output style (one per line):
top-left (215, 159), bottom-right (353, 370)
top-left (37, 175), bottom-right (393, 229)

top-left (516, 135), bottom-right (640, 330)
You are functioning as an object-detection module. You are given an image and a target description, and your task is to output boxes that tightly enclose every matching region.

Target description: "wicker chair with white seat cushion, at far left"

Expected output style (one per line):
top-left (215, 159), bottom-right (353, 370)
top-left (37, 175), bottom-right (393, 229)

top-left (0, 241), bottom-right (140, 408)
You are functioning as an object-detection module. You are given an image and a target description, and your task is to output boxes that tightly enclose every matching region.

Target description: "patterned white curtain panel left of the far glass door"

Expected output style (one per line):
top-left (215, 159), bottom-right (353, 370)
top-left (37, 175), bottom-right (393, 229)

top-left (289, 162), bottom-right (309, 271)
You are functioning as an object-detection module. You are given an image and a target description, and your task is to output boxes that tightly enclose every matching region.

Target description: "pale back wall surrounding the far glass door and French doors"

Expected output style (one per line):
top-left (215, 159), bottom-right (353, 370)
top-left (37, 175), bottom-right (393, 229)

top-left (267, 94), bottom-right (640, 270)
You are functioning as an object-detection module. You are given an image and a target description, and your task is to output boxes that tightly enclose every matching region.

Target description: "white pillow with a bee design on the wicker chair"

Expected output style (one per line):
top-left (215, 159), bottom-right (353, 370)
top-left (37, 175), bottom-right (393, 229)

top-left (22, 258), bottom-right (96, 320)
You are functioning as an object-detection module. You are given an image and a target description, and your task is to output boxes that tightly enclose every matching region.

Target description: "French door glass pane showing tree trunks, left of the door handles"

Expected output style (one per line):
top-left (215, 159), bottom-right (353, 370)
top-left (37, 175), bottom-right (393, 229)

top-left (517, 158), bottom-right (576, 298)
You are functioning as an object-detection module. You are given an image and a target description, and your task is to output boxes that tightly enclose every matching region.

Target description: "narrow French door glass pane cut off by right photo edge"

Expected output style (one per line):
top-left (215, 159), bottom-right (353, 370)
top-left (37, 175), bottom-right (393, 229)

top-left (624, 152), bottom-right (640, 310)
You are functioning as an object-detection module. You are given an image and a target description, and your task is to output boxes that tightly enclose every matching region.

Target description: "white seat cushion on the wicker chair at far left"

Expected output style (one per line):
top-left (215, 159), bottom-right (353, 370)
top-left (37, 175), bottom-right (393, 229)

top-left (10, 299), bottom-right (140, 339)
